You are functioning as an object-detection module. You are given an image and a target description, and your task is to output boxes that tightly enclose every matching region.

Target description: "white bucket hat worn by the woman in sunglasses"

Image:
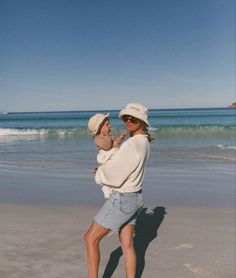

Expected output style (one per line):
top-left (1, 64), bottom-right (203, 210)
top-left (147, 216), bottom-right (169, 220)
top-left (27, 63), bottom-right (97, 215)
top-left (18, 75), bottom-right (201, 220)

top-left (119, 103), bottom-right (150, 126)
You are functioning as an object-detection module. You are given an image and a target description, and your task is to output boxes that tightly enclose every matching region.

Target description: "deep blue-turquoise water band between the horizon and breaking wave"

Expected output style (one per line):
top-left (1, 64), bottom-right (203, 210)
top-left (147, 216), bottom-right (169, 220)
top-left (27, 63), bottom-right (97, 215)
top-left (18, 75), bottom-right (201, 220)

top-left (0, 108), bottom-right (236, 129)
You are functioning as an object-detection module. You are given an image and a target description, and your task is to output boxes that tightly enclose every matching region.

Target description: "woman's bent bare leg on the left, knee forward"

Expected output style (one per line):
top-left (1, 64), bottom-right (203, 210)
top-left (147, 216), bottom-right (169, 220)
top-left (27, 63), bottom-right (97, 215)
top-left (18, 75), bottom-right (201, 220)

top-left (84, 221), bottom-right (110, 278)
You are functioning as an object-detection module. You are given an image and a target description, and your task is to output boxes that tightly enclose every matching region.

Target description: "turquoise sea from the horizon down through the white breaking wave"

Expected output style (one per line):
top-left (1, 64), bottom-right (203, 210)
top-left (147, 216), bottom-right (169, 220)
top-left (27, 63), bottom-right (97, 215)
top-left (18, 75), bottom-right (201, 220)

top-left (0, 108), bottom-right (236, 149)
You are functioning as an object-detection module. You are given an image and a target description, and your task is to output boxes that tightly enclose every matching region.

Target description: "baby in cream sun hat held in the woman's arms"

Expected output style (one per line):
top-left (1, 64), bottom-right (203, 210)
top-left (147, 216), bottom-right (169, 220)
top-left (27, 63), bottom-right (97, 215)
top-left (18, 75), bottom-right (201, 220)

top-left (88, 113), bottom-right (126, 199)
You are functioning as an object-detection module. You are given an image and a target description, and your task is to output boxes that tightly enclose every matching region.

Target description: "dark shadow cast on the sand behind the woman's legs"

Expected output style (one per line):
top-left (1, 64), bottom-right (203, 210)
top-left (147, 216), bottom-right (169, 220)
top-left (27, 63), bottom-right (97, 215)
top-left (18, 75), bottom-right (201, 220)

top-left (102, 207), bottom-right (166, 278)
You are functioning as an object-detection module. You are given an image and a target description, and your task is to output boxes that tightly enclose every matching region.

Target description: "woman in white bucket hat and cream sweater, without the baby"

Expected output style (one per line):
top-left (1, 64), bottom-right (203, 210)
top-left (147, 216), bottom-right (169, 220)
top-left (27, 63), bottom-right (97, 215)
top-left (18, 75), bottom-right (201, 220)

top-left (84, 103), bottom-right (151, 278)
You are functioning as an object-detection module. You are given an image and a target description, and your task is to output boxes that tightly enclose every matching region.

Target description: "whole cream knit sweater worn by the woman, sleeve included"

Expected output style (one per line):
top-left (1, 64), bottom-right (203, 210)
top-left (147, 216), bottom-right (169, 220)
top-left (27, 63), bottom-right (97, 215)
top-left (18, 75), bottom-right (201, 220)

top-left (95, 134), bottom-right (150, 193)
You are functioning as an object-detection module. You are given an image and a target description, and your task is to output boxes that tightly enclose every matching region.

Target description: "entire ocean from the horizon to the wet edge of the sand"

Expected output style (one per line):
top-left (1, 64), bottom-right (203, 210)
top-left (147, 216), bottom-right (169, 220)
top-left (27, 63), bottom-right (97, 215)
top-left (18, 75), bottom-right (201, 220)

top-left (0, 108), bottom-right (236, 207)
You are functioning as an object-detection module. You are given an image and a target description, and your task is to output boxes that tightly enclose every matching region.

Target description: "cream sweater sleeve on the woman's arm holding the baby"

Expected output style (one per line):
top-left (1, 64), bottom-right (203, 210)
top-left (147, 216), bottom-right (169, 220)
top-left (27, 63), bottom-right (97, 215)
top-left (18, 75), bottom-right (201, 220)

top-left (95, 141), bottom-right (140, 188)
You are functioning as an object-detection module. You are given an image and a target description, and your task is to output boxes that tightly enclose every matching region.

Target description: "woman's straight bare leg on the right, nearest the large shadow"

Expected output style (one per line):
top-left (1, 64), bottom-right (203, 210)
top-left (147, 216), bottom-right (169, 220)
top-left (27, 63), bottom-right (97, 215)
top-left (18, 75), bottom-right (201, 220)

top-left (119, 224), bottom-right (136, 278)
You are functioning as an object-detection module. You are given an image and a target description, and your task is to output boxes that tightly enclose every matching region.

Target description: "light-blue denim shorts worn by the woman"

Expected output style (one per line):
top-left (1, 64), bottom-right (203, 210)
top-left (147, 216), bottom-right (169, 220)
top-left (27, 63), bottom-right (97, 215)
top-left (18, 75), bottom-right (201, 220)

top-left (94, 191), bottom-right (143, 232)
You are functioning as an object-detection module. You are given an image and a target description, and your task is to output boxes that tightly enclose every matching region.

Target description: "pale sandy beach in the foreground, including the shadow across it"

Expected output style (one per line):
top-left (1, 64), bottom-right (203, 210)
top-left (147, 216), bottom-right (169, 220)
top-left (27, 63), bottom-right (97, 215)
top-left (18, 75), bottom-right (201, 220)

top-left (0, 204), bottom-right (235, 278)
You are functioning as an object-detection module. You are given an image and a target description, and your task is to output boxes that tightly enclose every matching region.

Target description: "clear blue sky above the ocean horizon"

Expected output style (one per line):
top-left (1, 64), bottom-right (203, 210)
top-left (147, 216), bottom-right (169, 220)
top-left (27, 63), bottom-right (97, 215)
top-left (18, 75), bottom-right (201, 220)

top-left (0, 0), bottom-right (235, 111)
